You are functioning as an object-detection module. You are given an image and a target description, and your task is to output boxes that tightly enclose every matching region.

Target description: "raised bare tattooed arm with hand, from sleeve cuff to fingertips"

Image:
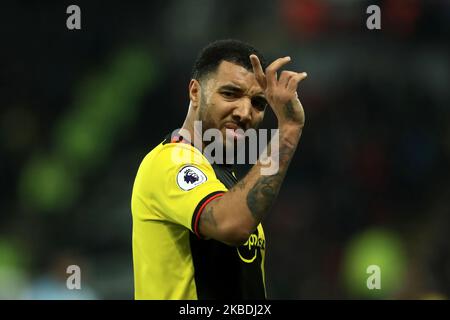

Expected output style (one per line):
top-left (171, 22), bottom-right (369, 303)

top-left (199, 55), bottom-right (306, 245)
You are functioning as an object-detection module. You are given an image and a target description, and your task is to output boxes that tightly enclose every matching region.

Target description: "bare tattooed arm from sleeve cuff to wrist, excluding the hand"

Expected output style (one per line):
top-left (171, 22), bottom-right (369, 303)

top-left (199, 126), bottom-right (302, 243)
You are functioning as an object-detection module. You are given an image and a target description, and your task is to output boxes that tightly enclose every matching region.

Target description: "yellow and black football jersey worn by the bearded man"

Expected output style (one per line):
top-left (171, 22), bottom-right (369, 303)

top-left (131, 135), bottom-right (266, 300)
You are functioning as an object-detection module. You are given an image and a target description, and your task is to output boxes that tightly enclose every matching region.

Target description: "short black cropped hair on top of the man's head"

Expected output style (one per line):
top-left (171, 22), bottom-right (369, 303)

top-left (191, 39), bottom-right (267, 81)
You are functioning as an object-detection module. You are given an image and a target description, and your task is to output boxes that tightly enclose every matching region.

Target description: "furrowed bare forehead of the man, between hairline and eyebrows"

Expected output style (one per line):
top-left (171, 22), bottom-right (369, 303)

top-left (207, 61), bottom-right (263, 94)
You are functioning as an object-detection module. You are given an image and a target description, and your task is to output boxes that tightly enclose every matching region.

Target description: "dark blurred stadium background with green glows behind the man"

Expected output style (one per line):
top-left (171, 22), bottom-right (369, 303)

top-left (0, 0), bottom-right (450, 299)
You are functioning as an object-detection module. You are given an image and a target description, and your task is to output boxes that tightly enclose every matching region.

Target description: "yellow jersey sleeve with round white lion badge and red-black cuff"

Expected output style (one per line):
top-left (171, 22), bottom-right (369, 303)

top-left (142, 143), bottom-right (227, 237)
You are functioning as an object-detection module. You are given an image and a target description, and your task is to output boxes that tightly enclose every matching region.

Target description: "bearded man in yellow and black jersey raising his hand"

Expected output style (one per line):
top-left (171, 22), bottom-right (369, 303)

top-left (132, 40), bottom-right (306, 299)
